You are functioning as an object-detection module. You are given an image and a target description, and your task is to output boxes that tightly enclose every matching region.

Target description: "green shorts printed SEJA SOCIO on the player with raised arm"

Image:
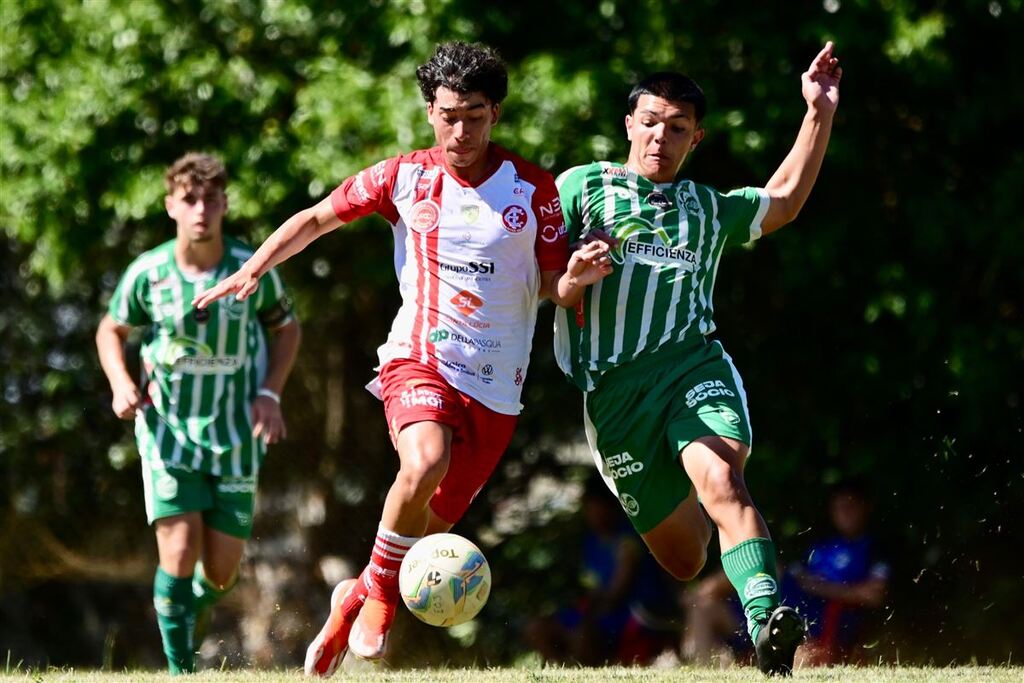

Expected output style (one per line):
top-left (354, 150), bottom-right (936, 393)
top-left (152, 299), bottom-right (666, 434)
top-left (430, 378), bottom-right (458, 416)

top-left (584, 339), bottom-right (751, 533)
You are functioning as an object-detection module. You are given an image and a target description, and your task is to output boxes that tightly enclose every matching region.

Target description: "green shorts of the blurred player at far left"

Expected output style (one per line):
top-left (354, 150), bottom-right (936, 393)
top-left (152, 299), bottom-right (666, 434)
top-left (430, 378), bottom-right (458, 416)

top-left (142, 455), bottom-right (258, 540)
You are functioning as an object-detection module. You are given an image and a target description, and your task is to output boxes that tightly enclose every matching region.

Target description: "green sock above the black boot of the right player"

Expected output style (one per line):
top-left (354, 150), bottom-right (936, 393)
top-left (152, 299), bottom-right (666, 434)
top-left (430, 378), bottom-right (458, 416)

top-left (722, 539), bottom-right (778, 641)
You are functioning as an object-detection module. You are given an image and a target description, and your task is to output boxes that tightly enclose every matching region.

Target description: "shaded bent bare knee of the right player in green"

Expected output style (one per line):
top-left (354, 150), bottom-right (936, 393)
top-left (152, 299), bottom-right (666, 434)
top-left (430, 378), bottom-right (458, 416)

top-left (642, 489), bottom-right (711, 581)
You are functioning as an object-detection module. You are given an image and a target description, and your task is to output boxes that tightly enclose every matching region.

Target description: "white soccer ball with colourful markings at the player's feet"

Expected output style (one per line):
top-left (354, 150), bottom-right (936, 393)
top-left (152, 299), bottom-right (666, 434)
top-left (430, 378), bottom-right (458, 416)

top-left (398, 533), bottom-right (490, 626)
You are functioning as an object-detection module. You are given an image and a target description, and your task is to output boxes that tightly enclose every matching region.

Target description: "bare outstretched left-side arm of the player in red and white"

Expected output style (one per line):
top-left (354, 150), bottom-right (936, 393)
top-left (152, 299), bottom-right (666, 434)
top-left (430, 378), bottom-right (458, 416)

top-left (193, 197), bottom-right (342, 308)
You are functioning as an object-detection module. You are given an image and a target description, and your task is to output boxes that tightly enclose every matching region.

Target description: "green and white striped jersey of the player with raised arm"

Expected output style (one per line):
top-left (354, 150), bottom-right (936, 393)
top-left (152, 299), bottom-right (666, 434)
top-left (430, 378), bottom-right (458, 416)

top-left (555, 162), bottom-right (769, 391)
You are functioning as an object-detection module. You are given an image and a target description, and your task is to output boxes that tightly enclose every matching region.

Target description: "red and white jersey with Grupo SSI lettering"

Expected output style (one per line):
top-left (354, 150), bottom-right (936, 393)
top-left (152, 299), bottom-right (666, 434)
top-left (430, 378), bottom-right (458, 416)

top-left (331, 144), bottom-right (568, 415)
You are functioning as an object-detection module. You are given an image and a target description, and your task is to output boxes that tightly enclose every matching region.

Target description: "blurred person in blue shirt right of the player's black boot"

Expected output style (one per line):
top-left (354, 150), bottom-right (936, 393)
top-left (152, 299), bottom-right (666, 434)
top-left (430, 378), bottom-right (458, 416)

top-left (782, 480), bottom-right (889, 666)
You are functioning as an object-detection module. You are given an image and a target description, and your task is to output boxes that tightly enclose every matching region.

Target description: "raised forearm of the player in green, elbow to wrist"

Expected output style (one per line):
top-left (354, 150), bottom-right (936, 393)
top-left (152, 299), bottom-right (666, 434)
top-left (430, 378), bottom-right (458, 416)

top-left (762, 108), bottom-right (834, 232)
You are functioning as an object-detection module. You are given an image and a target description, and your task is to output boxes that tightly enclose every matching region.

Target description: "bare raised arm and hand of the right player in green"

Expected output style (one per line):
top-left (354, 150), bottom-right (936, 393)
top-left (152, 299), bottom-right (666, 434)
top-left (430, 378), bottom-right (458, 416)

top-left (761, 41), bottom-right (843, 233)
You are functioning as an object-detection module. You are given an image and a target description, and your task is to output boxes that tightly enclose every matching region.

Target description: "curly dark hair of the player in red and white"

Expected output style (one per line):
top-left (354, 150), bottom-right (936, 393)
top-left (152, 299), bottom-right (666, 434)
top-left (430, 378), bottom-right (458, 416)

top-left (416, 42), bottom-right (509, 104)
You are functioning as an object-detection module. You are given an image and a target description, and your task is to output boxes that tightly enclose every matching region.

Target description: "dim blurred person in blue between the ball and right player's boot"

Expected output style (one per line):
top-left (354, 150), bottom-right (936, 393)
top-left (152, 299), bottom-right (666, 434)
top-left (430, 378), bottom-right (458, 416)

top-left (525, 475), bottom-right (679, 666)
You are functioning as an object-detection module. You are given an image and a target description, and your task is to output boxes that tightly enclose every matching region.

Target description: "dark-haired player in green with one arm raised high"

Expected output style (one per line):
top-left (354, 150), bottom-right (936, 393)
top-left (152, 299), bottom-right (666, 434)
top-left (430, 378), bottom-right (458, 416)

top-left (555, 42), bottom-right (842, 674)
